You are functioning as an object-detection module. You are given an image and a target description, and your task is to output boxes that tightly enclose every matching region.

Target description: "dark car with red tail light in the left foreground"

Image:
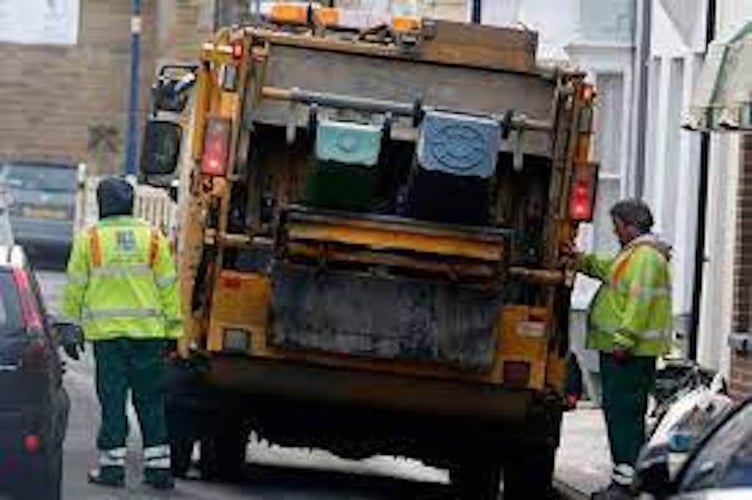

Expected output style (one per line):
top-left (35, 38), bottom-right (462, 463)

top-left (0, 246), bottom-right (70, 500)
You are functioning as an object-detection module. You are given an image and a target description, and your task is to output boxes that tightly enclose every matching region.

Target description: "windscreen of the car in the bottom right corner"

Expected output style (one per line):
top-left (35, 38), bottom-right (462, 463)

top-left (681, 403), bottom-right (752, 491)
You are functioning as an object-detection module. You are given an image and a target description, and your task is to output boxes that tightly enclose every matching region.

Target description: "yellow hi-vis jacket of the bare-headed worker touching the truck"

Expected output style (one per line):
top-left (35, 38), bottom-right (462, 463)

top-left (577, 236), bottom-right (672, 356)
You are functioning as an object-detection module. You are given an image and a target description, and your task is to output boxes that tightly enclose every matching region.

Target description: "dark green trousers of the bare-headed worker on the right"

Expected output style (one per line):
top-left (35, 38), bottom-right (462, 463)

top-left (600, 353), bottom-right (655, 467)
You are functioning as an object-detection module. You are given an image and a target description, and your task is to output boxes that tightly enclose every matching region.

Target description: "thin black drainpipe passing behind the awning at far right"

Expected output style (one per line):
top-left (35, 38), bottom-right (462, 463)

top-left (687, 0), bottom-right (716, 360)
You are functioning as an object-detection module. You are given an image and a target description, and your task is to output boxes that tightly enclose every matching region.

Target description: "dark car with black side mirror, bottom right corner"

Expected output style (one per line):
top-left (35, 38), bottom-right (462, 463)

top-left (638, 399), bottom-right (752, 500)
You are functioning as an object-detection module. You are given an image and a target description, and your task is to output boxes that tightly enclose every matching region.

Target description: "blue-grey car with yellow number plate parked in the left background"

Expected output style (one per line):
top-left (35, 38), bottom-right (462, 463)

top-left (0, 161), bottom-right (79, 254)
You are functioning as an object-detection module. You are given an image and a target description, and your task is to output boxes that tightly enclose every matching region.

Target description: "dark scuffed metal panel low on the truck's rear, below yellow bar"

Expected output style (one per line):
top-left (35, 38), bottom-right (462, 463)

top-left (269, 265), bottom-right (502, 371)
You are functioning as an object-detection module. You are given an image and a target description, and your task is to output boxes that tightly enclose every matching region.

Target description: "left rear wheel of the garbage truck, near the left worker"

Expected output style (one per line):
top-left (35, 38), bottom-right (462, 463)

top-left (199, 420), bottom-right (249, 481)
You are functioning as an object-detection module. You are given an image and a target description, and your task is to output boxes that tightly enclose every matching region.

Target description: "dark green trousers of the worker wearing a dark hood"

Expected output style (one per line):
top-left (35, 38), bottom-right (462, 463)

top-left (94, 339), bottom-right (168, 451)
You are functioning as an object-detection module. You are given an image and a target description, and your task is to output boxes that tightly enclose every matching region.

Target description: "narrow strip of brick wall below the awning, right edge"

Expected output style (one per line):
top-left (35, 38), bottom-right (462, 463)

top-left (731, 135), bottom-right (752, 395)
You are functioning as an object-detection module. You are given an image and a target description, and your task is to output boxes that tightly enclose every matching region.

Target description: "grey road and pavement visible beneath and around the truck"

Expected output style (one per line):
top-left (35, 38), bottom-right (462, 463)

top-left (33, 272), bottom-right (611, 500)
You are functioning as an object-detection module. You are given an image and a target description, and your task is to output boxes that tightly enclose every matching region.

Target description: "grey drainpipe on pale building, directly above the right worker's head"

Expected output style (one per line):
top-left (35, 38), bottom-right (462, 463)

top-left (634, 0), bottom-right (654, 198)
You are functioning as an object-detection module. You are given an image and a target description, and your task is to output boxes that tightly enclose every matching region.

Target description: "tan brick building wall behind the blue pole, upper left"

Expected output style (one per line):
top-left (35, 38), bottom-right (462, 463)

top-left (0, 0), bottom-right (213, 173)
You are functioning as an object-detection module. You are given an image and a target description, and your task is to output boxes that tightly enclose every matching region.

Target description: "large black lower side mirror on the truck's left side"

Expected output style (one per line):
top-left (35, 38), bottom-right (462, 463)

top-left (141, 120), bottom-right (183, 177)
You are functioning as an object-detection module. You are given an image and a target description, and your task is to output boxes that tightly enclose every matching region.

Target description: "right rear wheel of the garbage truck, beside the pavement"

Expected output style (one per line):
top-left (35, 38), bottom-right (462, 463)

top-left (504, 448), bottom-right (556, 500)
